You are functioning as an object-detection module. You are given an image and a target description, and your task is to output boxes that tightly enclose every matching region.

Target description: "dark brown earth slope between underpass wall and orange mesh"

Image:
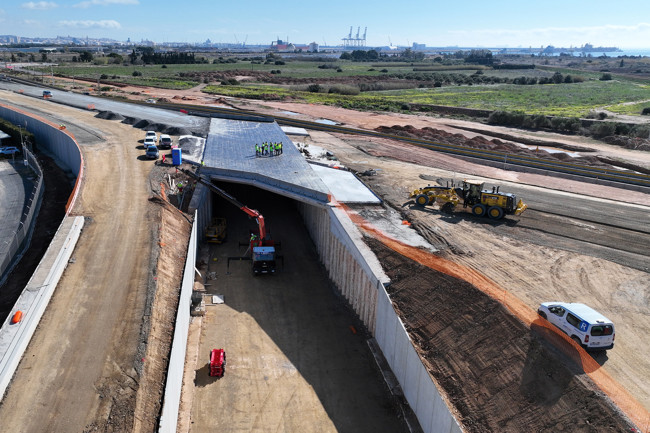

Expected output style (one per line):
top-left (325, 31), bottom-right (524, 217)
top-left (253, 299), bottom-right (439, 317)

top-left (366, 238), bottom-right (633, 433)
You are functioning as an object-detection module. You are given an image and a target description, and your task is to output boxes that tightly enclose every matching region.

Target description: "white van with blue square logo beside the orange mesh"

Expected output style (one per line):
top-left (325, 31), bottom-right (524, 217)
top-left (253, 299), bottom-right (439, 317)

top-left (537, 302), bottom-right (615, 351)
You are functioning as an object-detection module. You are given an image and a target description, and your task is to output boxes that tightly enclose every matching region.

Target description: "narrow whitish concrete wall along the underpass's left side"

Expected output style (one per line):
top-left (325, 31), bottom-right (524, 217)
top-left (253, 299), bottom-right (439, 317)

top-left (158, 212), bottom-right (197, 433)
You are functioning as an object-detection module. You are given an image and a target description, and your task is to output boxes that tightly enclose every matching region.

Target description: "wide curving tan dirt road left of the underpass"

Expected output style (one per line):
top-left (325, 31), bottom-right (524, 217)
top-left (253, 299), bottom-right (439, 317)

top-left (0, 92), bottom-right (153, 432)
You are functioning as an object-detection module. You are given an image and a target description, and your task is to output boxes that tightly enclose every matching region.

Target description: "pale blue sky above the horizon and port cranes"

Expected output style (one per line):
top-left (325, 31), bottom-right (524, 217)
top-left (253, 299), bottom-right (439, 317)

top-left (0, 0), bottom-right (650, 48)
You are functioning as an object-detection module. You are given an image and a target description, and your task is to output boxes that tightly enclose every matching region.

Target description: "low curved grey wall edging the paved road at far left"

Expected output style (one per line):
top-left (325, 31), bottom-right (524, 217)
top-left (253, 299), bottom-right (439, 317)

top-left (0, 150), bottom-right (45, 284)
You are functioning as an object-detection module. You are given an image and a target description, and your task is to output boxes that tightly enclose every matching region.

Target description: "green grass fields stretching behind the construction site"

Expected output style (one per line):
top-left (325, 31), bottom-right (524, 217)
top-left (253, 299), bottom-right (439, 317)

top-left (39, 59), bottom-right (650, 117)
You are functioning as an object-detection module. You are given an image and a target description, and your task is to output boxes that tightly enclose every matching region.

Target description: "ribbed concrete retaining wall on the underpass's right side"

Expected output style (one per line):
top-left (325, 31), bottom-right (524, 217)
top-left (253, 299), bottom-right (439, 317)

top-left (298, 203), bottom-right (462, 433)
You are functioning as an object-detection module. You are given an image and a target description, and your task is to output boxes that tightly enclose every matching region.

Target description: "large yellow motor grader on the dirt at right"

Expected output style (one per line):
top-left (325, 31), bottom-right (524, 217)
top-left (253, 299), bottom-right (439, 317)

top-left (410, 179), bottom-right (528, 220)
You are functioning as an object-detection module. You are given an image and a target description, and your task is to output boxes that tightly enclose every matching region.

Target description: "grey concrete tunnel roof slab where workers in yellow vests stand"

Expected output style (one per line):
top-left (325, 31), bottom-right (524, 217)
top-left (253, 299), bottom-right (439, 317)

top-left (201, 119), bottom-right (330, 206)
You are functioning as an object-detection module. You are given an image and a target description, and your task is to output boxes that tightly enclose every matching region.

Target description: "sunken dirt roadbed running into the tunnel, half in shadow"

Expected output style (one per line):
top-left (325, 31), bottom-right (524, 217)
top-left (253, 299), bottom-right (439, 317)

top-left (190, 184), bottom-right (405, 433)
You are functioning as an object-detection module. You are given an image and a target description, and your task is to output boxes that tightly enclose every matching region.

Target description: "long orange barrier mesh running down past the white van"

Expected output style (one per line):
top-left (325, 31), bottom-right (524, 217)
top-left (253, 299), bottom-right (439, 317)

top-left (339, 204), bottom-right (650, 433)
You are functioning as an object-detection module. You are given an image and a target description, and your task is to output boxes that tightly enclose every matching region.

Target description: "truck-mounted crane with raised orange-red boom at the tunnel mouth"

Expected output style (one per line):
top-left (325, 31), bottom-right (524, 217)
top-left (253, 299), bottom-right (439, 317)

top-left (179, 168), bottom-right (282, 275)
